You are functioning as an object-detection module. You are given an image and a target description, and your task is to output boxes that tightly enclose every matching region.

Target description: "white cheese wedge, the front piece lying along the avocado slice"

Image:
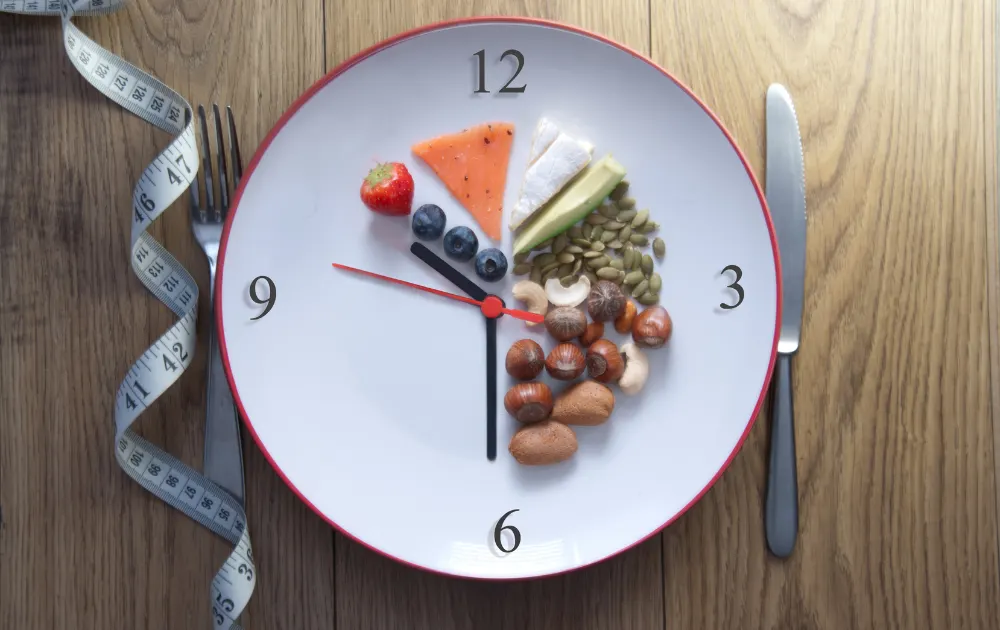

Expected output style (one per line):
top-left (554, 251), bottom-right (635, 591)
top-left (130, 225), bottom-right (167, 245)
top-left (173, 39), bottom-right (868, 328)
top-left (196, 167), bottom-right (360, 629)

top-left (510, 132), bottom-right (594, 230)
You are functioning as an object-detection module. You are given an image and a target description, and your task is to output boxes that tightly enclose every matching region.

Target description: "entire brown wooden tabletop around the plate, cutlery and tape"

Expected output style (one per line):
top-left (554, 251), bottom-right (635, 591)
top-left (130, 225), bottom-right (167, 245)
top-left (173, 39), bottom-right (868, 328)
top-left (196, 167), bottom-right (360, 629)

top-left (0, 0), bottom-right (1000, 630)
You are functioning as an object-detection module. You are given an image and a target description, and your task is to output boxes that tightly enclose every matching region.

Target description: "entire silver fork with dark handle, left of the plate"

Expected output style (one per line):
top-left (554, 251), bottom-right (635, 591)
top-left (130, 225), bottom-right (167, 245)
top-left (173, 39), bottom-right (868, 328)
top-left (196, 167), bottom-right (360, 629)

top-left (190, 103), bottom-right (244, 506)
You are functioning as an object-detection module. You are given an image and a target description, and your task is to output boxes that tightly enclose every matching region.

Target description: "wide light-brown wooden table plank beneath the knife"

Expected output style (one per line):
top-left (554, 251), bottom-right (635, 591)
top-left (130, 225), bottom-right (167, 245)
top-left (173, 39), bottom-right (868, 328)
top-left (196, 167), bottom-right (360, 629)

top-left (652, 0), bottom-right (998, 630)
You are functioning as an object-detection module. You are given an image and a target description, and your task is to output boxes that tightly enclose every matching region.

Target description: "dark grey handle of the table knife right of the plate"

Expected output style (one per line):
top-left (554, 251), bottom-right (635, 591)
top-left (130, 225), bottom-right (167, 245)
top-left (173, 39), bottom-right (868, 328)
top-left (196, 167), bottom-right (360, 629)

top-left (764, 354), bottom-right (799, 558)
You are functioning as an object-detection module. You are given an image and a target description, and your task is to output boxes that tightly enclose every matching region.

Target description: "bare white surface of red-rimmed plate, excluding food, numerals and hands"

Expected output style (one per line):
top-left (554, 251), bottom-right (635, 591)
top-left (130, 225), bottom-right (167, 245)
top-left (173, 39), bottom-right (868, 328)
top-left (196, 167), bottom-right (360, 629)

top-left (216, 18), bottom-right (780, 579)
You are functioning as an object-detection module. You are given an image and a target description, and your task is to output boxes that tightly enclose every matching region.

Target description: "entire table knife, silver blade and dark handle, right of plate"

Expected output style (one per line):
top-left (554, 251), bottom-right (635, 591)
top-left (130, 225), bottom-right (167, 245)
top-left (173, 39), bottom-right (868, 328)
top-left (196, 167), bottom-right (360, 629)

top-left (764, 83), bottom-right (806, 558)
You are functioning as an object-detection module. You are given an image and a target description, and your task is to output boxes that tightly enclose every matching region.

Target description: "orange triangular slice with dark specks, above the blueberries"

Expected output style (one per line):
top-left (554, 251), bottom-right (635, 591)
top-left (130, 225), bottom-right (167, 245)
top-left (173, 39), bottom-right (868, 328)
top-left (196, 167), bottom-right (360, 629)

top-left (411, 122), bottom-right (514, 241)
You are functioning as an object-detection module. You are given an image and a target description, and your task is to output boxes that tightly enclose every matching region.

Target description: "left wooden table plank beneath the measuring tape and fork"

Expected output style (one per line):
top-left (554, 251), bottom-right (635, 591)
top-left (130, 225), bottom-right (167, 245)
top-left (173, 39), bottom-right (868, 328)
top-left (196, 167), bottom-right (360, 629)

top-left (0, 0), bottom-right (333, 628)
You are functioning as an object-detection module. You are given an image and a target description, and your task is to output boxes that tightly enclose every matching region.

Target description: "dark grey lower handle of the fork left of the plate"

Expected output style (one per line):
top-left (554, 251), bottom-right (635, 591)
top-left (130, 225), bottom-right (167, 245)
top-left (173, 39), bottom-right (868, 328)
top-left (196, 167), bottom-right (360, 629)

top-left (204, 288), bottom-right (244, 504)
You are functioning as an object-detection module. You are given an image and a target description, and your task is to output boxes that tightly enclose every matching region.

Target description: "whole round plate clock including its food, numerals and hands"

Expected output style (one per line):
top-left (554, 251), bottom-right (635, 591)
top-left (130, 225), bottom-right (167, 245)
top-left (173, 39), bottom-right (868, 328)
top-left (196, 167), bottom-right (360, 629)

top-left (216, 19), bottom-right (780, 579)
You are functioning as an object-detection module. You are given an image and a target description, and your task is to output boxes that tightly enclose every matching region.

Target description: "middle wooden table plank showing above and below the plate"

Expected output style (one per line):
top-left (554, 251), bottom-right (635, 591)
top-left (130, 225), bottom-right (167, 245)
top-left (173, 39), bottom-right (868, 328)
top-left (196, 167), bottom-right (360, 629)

top-left (327, 0), bottom-right (664, 630)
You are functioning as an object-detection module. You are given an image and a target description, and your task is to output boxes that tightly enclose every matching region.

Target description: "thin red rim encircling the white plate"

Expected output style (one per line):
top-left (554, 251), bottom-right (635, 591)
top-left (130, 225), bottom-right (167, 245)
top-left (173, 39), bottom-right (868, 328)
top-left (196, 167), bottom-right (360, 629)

top-left (214, 16), bottom-right (781, 582)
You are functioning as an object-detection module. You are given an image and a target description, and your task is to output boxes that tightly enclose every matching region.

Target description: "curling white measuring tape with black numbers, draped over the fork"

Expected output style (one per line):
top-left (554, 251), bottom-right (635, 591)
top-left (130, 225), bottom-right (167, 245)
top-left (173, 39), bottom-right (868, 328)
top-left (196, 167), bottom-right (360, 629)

top-left (0, 0), bottom-right (257, 629)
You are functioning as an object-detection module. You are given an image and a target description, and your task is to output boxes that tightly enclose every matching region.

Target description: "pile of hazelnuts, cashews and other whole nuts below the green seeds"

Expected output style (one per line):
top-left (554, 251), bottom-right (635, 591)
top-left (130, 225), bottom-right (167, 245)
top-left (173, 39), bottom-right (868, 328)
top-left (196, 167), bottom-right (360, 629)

top-left (504, 276), bottom-right (673, 465)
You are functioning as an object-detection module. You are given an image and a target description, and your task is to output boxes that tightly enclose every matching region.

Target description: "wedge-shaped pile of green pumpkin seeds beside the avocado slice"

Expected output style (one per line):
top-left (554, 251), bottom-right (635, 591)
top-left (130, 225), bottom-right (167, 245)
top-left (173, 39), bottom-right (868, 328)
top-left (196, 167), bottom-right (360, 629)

top-left (514, 181), bottom-right (666, 305)
